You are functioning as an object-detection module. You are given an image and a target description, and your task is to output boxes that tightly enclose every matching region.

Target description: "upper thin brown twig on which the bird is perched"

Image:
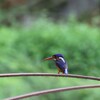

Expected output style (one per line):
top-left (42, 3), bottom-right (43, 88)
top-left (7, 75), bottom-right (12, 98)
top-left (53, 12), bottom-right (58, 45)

top-left (0, 73), bottom-right (100, 81)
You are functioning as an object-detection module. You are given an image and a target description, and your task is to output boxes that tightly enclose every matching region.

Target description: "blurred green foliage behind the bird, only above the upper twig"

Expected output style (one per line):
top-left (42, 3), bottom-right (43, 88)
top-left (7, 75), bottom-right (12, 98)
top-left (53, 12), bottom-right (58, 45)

top-left (0, 19), bottom-right (100, 75)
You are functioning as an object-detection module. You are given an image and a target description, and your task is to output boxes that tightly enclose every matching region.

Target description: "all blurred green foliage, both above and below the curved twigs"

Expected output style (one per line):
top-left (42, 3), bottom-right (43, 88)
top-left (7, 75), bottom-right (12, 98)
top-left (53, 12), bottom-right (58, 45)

top-left (0, 19), bottom-right (100, 100)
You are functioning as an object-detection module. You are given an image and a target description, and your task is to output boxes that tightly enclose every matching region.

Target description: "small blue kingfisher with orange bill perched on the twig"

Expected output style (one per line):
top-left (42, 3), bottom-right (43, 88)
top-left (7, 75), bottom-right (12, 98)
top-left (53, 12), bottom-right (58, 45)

top-left (44, 54), bottom-right (68, 74)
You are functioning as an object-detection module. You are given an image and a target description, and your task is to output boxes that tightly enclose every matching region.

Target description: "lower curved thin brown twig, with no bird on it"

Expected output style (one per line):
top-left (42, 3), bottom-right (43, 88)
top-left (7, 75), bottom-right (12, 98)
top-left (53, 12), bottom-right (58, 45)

top-left (4, 84), bottom-right (100, 100)
